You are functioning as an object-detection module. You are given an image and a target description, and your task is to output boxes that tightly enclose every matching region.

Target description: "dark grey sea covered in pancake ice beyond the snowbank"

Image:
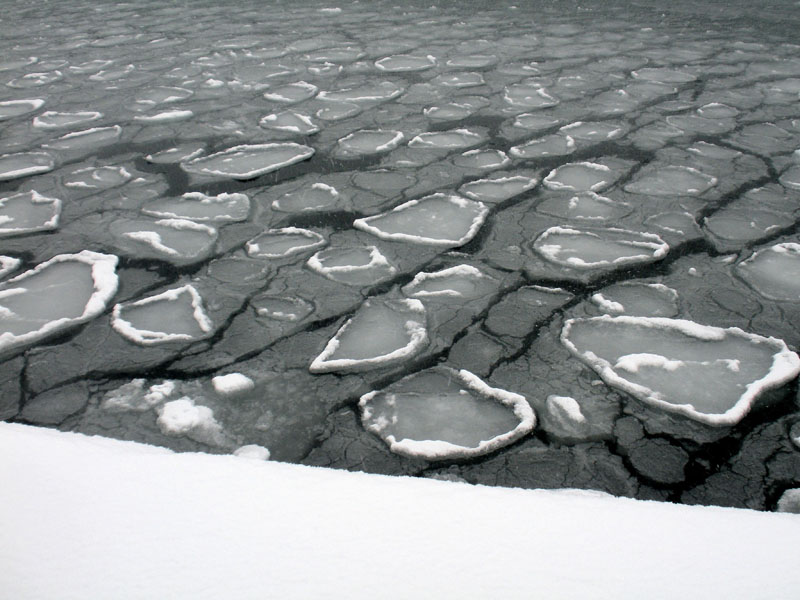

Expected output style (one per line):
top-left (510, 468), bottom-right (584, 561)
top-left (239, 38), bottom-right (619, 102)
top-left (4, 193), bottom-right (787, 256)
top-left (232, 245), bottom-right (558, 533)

top-left (0, 1), bottom-right (800, 512)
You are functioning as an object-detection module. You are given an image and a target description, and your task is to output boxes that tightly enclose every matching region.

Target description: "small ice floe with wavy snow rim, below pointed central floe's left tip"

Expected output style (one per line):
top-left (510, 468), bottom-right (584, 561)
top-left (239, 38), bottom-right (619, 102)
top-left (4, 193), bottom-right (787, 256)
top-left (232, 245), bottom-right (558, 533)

top-left (306, 246), bottom-right (397, 286)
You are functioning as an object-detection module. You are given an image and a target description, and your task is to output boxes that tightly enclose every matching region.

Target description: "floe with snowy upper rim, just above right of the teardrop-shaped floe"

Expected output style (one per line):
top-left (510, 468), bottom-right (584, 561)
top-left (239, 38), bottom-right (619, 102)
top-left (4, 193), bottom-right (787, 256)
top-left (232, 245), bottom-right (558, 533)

top-left (402, 265), bottom-right (497, 301)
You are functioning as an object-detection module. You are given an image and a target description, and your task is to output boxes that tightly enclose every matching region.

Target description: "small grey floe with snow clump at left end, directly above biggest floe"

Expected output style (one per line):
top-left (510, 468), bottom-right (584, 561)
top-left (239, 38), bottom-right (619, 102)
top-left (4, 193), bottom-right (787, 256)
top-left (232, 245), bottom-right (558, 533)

top-left (591, 282), bottom-right (678, 317)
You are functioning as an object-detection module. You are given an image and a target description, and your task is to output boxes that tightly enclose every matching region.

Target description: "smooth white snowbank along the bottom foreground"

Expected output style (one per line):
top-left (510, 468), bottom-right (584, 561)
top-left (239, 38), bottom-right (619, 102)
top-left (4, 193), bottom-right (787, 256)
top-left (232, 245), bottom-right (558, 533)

top-left (0, 423), bottom-right (800, 600)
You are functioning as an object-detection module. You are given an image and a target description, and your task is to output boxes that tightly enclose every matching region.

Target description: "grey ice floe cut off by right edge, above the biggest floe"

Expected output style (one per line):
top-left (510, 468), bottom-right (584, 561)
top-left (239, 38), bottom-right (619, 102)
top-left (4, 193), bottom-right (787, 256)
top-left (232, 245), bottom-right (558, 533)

top-left (734, 242), bottom-right (800, 302)
